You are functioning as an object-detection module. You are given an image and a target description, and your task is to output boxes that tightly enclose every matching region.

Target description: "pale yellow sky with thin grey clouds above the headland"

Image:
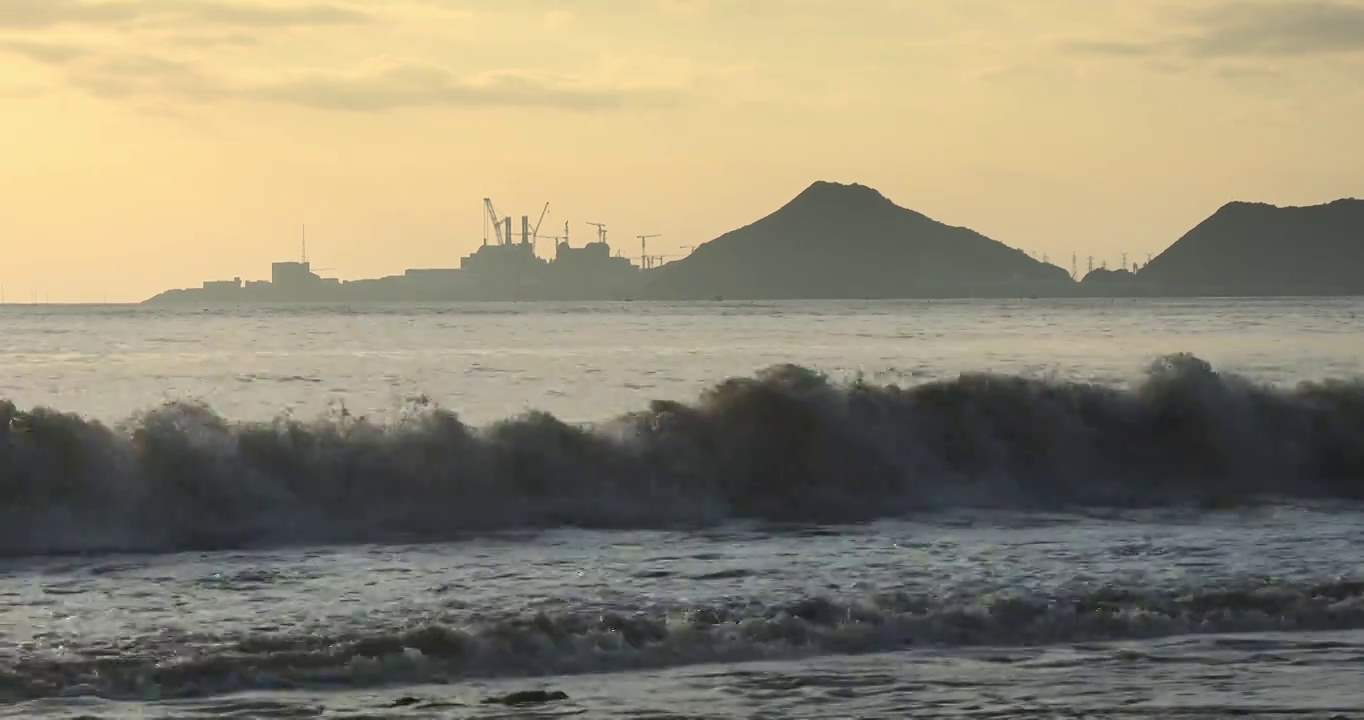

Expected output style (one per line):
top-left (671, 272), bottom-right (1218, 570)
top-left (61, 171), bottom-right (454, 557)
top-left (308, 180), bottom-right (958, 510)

top-left (0, 0), bottom-right (1364, 301)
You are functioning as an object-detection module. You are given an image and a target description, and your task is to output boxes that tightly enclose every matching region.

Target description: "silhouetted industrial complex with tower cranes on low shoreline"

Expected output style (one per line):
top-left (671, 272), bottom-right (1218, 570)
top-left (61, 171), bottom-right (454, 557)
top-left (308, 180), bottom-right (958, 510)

top-left (147, 198), bottom-right (662, 303)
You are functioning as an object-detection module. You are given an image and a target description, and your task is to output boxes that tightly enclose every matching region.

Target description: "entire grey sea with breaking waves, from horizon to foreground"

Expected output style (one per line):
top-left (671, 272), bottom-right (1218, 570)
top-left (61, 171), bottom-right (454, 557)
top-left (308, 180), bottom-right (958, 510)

top-left (0, 299), bottom-right (1364, 720)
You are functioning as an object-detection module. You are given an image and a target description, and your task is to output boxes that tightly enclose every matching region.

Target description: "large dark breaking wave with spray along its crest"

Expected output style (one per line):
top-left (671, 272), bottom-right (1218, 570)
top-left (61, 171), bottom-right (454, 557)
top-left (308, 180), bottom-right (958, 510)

top-left (0, 355), bottom-right (1364, 556)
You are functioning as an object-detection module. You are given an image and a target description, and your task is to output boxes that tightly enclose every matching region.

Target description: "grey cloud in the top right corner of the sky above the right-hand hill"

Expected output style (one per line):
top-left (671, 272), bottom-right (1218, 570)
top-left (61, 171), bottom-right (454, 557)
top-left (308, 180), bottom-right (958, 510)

top-left (1063, 0), bottom-right (1364, 60)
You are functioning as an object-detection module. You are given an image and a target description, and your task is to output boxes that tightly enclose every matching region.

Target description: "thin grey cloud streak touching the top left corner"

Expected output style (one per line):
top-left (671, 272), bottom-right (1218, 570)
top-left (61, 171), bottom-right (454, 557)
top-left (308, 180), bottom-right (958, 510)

top-left (0, 0), bottom-right (372, 30)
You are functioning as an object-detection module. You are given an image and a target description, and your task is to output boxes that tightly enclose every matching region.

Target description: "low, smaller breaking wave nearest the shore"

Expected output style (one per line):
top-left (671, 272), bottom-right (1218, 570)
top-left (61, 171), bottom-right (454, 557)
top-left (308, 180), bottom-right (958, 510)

top-left (0, 580), bottom-right (1364, 701)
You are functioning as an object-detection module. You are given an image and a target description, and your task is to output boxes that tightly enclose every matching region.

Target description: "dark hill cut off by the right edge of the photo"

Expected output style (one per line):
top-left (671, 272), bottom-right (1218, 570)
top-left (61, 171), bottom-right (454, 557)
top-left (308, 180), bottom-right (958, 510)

top-left (1138, 199), bottom-right (1364, 296)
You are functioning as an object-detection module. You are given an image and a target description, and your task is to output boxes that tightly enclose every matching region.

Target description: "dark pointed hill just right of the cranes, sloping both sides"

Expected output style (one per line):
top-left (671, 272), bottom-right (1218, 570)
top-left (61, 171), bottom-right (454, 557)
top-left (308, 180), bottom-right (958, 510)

top-left (647, 181), bottom-right (1073, 300)
